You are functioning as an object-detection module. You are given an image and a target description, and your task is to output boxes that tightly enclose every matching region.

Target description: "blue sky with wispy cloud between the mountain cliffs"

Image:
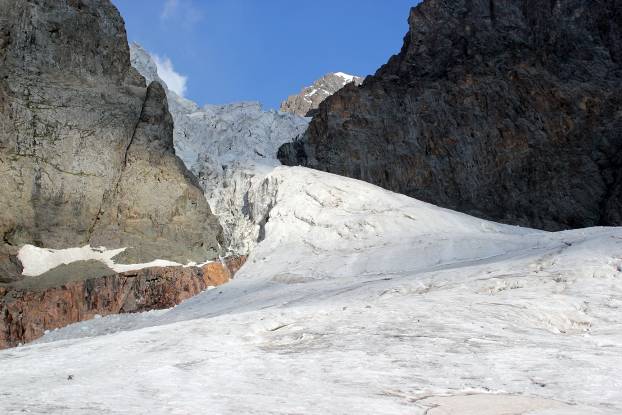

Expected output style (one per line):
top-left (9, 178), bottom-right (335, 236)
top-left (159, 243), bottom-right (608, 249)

top-left (112, 0), bottom-right (417, 108)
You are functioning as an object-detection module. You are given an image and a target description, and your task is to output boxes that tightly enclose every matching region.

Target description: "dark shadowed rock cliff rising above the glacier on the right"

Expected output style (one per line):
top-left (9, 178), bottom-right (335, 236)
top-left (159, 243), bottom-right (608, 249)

top-left (279, 0), bottom-right (622, 230)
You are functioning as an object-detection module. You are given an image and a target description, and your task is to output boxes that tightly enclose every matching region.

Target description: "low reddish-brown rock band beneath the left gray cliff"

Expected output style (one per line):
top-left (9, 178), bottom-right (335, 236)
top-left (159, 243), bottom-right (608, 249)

top-left (0, 257), bottom-right (246, 349)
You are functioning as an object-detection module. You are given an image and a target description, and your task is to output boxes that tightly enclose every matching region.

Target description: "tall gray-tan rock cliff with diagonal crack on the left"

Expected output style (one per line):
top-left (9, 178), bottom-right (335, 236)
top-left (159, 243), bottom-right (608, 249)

top-left (0, 0), bottom-right (221, 280)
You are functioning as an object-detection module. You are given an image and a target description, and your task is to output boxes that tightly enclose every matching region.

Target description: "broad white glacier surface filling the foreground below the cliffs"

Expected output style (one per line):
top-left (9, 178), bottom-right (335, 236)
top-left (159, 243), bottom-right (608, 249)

top-left (0, 167), bottom-right (622, 415)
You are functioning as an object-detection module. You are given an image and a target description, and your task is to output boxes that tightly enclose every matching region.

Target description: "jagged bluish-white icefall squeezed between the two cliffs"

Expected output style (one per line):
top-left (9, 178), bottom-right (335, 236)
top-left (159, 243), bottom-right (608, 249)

top-left (130, 43), bottom-right (309, 255)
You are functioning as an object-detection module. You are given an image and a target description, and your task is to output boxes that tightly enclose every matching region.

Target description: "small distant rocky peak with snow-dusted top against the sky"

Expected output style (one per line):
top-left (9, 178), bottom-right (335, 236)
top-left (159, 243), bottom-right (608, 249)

top-left (280, 72), bottom-right (363, 117)
